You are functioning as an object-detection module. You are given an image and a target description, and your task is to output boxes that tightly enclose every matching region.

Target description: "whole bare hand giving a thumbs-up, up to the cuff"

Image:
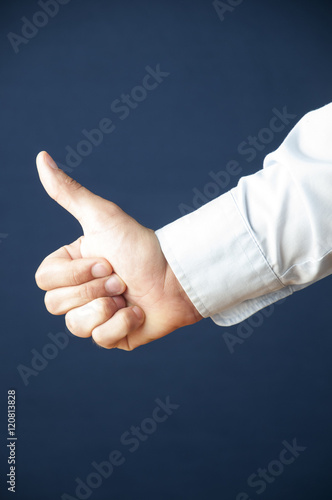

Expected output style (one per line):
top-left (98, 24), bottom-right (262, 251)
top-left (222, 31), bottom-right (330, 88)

top-left (36, 152), bottom-right (202, 350)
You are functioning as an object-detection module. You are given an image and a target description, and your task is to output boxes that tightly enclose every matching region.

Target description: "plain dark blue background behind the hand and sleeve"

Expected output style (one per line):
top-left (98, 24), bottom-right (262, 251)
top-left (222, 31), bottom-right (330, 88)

top-left (0, 0), bottom-right (332, 500)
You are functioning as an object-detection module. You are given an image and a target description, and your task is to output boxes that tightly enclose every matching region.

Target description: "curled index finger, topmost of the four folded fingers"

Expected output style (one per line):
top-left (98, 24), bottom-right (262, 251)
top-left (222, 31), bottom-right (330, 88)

top-left (36, 254), bottom-right (113, 291)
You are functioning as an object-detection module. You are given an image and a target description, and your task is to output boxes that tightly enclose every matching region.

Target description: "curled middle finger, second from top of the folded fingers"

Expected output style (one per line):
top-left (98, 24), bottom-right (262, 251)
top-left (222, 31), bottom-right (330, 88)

top-left (45, 273), bottom-right (126, 316)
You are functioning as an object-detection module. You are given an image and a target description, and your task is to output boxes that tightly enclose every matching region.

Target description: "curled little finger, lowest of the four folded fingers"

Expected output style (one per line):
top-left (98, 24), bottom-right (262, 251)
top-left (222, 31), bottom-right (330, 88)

top-left (92, 306), bottom-right (145, 350)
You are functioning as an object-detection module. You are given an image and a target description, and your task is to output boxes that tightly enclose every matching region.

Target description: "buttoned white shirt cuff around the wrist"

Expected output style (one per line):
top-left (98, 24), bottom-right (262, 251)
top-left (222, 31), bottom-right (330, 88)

top-left (156, 191), bottom-right (292, 326)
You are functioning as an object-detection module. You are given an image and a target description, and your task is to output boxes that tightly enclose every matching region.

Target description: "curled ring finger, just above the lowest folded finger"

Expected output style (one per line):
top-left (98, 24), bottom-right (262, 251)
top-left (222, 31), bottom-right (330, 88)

top-left (66, 296), bottom-right (126, 337)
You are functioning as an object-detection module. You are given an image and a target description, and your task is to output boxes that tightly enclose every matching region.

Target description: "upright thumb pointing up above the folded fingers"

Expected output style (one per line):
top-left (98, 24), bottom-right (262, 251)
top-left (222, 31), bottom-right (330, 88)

top-left (36, 151), bottom-right (105, 225)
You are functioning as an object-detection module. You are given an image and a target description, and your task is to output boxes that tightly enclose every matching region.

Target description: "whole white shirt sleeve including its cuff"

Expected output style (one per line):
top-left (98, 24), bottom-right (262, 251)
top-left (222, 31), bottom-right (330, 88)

top-left (156, 103), bottom-right (332, 326)
